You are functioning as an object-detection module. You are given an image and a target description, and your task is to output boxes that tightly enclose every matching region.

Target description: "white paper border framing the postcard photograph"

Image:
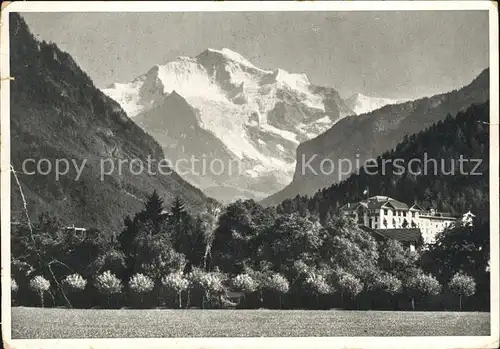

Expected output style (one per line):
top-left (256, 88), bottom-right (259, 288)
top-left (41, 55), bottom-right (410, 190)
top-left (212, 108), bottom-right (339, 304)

top-left (0, 1), bottom-right (500, 349)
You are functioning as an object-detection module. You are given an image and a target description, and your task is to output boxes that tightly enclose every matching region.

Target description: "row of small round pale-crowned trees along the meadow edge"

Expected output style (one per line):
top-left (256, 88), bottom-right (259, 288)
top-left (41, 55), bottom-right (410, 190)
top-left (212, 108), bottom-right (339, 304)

top-left (11, 264), bottom-right (476, 310)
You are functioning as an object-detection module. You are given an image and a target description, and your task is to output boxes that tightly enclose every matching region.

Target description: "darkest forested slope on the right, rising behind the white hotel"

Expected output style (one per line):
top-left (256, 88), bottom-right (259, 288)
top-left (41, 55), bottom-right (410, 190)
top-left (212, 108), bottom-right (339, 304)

top-left (278, 102), bottom-right (489, 222)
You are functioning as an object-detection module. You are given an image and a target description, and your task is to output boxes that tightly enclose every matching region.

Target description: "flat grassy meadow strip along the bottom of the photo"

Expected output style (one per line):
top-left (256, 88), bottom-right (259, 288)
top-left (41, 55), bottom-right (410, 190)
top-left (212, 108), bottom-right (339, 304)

top-left (12, 307), bottom-right (490, 339)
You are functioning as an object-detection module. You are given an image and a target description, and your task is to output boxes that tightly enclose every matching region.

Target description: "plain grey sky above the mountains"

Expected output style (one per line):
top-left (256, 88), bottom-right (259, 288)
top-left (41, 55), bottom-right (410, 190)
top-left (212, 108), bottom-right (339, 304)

top-left (22, 11), bottom-right (489, 98)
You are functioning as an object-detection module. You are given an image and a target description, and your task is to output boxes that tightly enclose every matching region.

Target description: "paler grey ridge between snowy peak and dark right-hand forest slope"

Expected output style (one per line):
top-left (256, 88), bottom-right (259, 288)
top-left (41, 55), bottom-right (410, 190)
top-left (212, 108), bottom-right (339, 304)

top-left (262, 69), bottom-right (489, 205)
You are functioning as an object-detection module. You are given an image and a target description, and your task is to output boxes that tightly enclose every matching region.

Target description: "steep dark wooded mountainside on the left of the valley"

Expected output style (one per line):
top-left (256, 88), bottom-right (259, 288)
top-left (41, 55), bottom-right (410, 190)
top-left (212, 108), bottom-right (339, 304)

top-left (10, 13), bottom-right (212, 231)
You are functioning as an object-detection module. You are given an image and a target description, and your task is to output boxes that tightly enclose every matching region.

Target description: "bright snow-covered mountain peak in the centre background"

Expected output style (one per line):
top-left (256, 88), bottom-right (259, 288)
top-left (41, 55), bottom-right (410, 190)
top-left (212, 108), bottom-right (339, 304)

top-left (103, 48), bottom-right (353, 203)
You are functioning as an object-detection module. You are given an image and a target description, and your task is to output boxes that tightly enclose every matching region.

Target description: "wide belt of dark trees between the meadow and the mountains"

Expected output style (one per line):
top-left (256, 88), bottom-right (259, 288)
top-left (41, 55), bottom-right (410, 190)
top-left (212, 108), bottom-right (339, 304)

top-left (12, 193), bottom-right (489, 308)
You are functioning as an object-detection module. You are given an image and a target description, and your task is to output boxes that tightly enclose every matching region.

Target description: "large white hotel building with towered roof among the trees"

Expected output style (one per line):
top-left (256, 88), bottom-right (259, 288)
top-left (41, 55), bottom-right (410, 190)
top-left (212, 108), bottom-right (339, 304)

top-left (339, 196), bottom-right (456, 249)
